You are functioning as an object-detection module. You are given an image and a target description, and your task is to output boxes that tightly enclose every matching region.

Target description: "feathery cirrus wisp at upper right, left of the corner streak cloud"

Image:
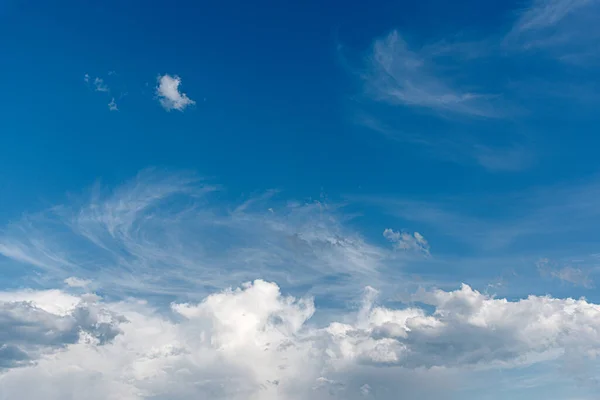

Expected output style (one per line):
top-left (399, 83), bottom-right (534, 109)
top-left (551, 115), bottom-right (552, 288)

top-left (353, 31), bottom-right (535, 172)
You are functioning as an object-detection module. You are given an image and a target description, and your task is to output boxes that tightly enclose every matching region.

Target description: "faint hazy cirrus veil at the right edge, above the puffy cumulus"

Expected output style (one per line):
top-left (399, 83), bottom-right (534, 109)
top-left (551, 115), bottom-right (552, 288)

top-left (349, 175), bottom-right (600, 251)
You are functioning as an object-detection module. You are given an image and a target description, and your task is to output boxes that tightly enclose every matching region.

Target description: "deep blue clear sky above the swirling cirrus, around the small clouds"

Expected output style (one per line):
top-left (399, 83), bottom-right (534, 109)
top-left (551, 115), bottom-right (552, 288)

top-left (0, 1), bottom-right (597, 211)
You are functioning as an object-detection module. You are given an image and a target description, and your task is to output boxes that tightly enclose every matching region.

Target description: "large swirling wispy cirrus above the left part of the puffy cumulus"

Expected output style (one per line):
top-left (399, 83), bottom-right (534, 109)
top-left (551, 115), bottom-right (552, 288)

top-left (0, 171), bottom-right (390, 302)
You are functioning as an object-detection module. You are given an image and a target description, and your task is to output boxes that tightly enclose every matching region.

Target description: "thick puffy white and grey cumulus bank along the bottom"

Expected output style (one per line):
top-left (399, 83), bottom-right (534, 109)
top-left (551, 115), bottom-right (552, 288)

top-left (0, 280), bottom-right (600, 400)
